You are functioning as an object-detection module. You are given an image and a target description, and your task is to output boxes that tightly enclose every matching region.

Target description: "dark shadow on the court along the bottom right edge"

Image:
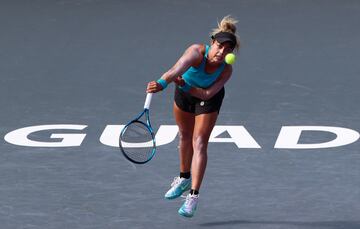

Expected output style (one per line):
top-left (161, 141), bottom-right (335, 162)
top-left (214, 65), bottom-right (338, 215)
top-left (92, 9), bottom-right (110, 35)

top-left (200, 220), bottom-right (360, 229)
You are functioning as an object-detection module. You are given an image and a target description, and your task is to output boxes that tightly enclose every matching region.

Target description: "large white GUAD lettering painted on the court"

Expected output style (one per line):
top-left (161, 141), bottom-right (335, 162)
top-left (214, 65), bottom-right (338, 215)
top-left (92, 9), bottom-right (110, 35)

top-left (4, 124), bottom-right (360, 149)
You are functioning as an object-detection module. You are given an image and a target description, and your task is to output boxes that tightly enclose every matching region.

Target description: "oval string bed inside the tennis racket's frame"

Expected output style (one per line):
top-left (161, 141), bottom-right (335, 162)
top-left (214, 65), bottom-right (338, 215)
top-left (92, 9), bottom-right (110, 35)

top-left (120, 122), bottom-right (155, 162)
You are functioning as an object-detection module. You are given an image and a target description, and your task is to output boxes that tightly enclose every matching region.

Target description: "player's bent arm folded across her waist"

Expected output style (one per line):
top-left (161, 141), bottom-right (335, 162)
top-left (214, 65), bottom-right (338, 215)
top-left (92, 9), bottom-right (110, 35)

top-left (189, 64), bottom-right (232, 100)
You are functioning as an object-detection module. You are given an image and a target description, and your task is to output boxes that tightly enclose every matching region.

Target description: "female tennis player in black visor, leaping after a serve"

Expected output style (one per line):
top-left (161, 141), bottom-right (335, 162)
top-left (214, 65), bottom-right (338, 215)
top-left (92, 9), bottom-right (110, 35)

top-left (147, 16), bottom-right (240, 217)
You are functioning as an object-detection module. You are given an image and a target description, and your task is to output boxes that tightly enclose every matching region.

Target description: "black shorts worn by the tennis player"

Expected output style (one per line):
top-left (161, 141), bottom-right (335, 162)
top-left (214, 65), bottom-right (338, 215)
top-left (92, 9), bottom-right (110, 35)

top-left (174, 87), bottom-right (225, 115)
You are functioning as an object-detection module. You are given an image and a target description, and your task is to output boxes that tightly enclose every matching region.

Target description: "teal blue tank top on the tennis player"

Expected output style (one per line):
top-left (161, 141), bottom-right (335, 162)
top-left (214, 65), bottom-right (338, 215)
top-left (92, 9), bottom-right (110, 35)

top-left (182, 45), bottom-right (225, 88)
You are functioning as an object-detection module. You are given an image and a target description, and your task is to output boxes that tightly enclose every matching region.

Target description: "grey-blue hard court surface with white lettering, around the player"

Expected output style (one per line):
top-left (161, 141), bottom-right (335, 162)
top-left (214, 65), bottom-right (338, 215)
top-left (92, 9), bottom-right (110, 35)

top-left (0, 0), bottom-right (360, 229)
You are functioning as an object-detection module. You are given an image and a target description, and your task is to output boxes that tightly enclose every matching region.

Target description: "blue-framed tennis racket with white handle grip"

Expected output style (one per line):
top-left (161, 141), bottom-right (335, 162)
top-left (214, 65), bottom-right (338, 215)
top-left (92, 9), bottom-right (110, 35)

top-left (119, 93), bottom-right (156, 164)
